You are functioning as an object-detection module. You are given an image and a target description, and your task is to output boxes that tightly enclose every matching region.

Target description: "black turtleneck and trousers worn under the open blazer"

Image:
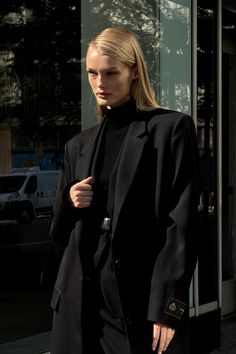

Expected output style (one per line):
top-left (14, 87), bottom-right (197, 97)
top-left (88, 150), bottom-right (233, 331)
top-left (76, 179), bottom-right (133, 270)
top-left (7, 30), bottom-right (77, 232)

top-left (84, 100), bottom-right (136, 354)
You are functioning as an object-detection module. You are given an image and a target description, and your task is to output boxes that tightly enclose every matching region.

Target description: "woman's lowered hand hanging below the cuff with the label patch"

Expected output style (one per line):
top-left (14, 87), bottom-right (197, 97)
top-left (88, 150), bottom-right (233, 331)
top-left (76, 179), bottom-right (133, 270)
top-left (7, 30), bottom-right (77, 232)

top-left (152, 323), bottom-right (175, 354)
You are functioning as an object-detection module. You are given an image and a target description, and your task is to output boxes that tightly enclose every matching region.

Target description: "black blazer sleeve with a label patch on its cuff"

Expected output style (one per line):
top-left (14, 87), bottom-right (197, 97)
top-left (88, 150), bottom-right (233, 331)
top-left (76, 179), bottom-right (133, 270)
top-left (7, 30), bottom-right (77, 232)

top-left (148, 115), bottom-right (199, 328)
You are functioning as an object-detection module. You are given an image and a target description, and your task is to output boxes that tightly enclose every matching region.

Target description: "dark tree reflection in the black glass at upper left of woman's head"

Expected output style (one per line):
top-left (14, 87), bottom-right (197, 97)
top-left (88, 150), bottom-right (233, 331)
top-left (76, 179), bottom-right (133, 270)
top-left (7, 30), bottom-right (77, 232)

top-left (0, 0), bottom-right (80, 149)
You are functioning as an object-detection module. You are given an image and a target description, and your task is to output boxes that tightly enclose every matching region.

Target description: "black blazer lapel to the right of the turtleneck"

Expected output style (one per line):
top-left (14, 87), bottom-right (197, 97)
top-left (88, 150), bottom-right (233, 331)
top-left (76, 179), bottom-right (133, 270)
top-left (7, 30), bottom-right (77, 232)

top-left (112, 121), bottom-right (148, 236)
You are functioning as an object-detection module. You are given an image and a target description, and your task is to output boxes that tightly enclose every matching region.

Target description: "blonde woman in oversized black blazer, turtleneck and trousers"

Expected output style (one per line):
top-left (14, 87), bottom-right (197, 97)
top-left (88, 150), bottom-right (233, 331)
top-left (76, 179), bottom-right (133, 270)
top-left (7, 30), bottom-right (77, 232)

top-left (51, 28), bottom-right (198, 354)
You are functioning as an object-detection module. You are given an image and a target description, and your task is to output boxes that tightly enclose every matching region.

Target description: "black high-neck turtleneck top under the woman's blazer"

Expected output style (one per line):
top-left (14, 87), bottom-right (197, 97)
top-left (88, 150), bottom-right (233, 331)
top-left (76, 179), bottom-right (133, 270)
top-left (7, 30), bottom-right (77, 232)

top-left (96, 99), bottom-right (136, 217)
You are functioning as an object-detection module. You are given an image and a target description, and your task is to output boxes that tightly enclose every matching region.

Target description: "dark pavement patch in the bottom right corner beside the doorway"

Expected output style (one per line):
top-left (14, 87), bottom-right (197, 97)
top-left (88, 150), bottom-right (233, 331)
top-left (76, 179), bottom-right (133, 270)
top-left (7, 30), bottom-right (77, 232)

top-left (210, 314), bottom-right (236, 354)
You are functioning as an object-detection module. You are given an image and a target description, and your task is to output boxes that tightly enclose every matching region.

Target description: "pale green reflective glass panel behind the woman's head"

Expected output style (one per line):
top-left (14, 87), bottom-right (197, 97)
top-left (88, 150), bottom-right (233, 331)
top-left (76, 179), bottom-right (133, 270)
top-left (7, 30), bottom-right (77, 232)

top-left (81, 0), bottom-right (191, 129)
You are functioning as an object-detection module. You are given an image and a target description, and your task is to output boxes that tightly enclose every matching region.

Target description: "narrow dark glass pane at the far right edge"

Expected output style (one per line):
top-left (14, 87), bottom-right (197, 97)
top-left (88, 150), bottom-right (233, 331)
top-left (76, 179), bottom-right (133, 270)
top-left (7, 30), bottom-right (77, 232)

top-left (222, 2), bottom-right (236, 281)
